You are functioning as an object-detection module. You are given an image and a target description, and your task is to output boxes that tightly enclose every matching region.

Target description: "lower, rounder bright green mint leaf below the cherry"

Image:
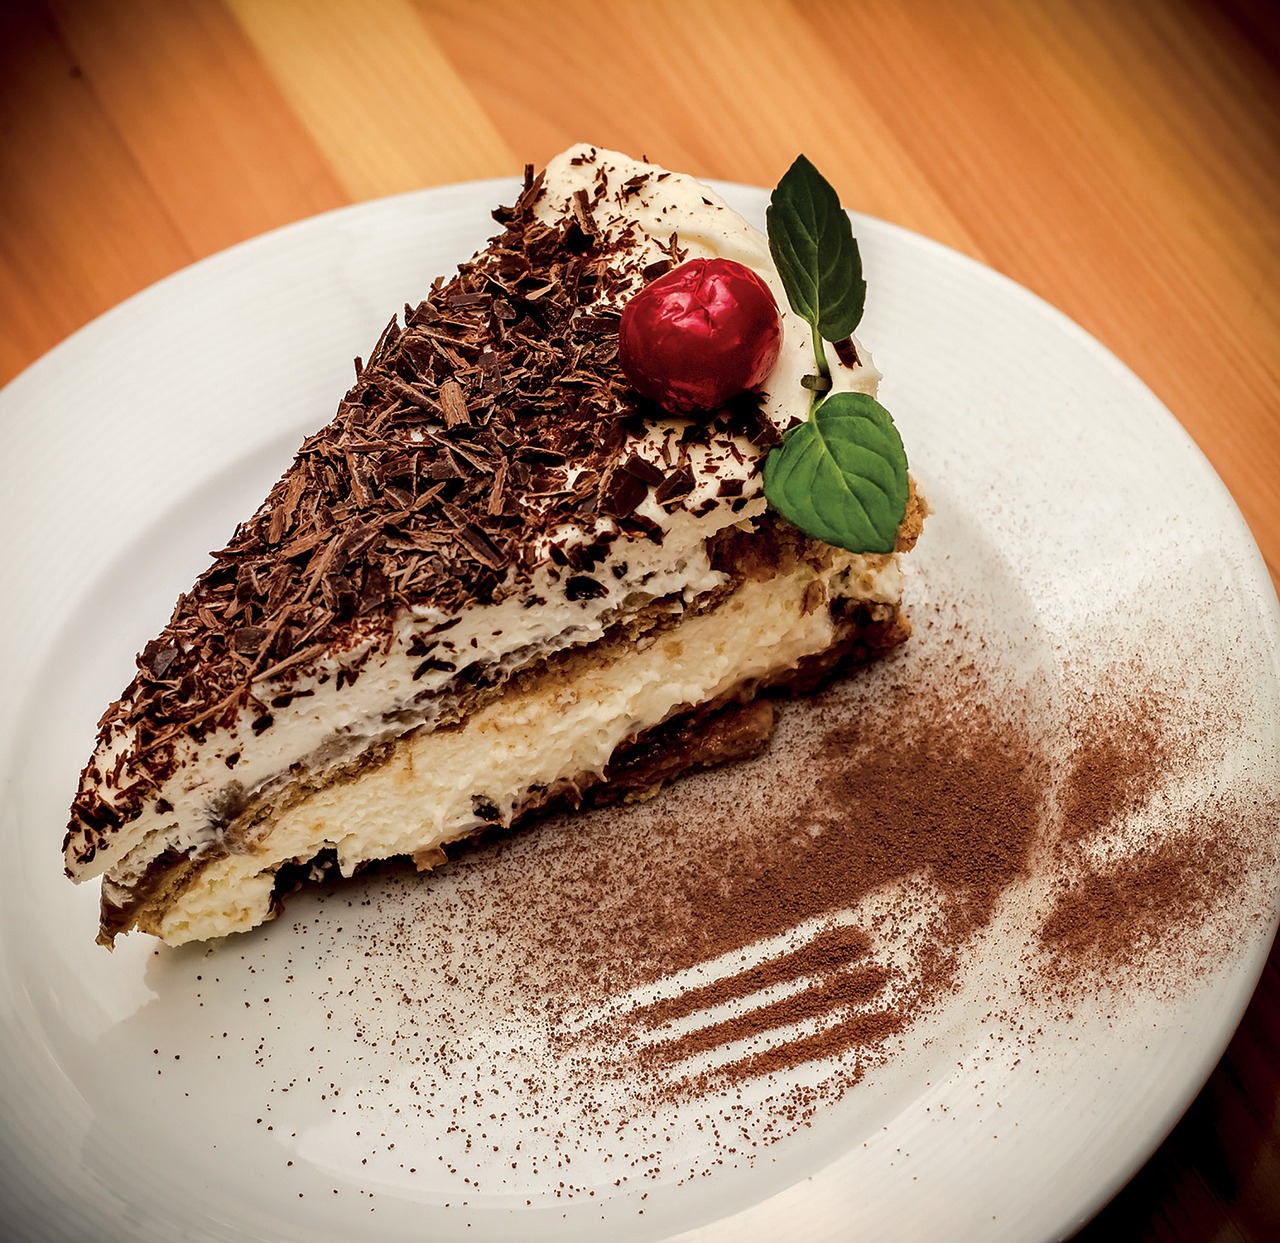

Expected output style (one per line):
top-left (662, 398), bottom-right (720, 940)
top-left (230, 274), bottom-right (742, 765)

top-left (764, 393), bottom-right (908, 553)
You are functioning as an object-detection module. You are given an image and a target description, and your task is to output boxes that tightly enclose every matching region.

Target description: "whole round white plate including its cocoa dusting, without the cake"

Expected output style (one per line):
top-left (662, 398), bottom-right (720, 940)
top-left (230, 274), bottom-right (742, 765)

top-left (0, 182), bottom-right (1280, 1240)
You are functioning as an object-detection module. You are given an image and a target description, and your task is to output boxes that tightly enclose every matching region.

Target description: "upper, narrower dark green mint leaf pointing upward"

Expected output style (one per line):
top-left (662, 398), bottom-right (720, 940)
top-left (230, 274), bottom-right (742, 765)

top-left (765, 155), bottom-right (867, 341)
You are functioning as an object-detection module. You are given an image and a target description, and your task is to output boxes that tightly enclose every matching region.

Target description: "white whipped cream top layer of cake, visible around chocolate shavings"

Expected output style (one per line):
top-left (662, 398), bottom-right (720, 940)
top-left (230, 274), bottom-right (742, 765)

top-left (65, 146), bottom-right (901, 887)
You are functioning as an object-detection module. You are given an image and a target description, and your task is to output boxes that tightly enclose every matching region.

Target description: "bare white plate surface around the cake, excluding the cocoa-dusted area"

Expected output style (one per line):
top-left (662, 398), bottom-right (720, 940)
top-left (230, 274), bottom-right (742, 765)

top-left (0, 182), bottom-right (1280, 1240)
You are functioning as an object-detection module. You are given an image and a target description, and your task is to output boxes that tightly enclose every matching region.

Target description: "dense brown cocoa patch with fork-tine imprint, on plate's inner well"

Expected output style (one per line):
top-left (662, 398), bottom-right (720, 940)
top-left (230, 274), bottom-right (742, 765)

top-left (593, 670), bottom-right (1044, 1089)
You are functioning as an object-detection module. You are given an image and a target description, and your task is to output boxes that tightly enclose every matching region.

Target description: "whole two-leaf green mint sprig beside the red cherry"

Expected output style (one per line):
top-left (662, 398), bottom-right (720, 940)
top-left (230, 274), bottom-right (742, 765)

top-left (764, 155), bottom-right (908, 553)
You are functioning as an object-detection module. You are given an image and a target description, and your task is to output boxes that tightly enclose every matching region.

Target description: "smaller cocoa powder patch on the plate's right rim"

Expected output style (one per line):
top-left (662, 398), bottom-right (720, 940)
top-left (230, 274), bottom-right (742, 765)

top-left (1024, 673), bottom-right (1265, 998)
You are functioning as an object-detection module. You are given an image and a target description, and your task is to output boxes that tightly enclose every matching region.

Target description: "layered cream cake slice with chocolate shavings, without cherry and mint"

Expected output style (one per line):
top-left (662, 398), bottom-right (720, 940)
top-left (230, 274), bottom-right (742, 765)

top-left (64, 146), bottom-right (923, 946)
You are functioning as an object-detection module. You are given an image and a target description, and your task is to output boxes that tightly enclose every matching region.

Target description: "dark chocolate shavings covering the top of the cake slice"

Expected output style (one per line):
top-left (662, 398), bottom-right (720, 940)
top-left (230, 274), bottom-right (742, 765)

top-left (64, 162), bottom-right (793, 865)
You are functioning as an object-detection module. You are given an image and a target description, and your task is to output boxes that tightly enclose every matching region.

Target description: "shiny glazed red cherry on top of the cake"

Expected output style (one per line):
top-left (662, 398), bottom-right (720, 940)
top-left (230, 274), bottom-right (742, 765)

top-left (618, 259), bottom-right (782, 413)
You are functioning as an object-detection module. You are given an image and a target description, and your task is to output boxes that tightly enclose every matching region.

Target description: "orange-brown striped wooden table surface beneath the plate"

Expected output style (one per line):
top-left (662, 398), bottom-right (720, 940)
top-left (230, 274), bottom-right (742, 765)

top-left (0, 0), bottom-right (1280, 1243)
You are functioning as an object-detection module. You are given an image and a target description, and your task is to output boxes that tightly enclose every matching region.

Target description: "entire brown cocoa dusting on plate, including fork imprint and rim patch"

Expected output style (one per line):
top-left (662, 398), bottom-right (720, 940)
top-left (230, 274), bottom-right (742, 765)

top-left (199, 609), bottom-right (1276, 1212)
